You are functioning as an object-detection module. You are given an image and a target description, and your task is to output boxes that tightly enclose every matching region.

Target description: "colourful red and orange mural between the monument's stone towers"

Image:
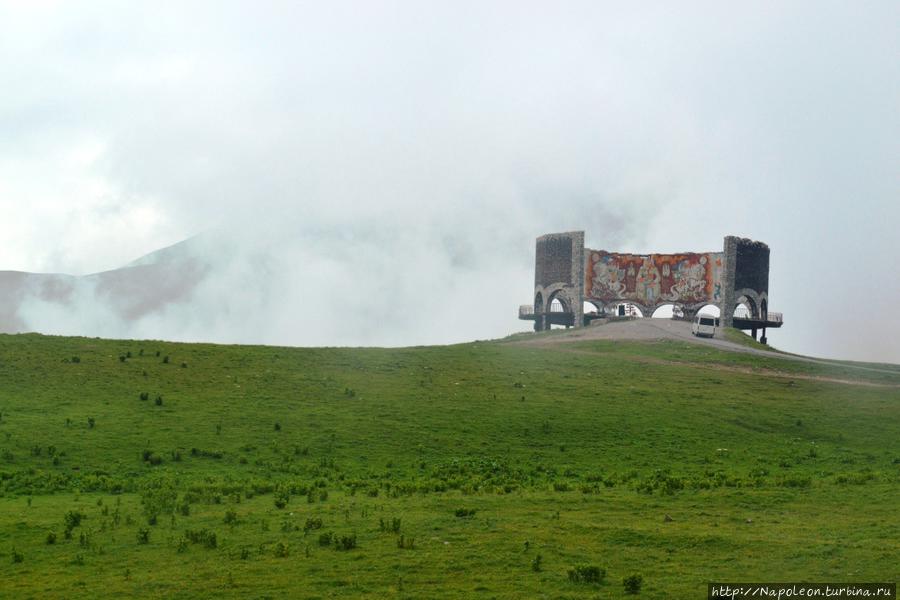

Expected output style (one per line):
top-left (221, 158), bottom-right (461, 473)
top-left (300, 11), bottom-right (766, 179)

top-left (584, 250), bottom-right (724, 307)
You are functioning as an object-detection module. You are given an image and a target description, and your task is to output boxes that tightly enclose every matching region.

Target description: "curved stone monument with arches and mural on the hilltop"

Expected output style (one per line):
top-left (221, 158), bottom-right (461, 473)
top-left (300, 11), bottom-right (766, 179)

top-left (533, 231), bottom-right (769, 330)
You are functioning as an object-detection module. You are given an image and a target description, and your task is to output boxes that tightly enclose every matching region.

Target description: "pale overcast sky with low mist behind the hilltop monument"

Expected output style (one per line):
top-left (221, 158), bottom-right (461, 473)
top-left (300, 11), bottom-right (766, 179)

top-left (0, 0), bottom-right (900, 362)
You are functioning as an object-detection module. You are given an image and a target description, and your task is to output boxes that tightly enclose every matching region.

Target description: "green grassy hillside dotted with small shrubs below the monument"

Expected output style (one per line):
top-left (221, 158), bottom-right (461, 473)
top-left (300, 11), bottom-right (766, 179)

top-left (0, 335), bottom-right (900, 598)
